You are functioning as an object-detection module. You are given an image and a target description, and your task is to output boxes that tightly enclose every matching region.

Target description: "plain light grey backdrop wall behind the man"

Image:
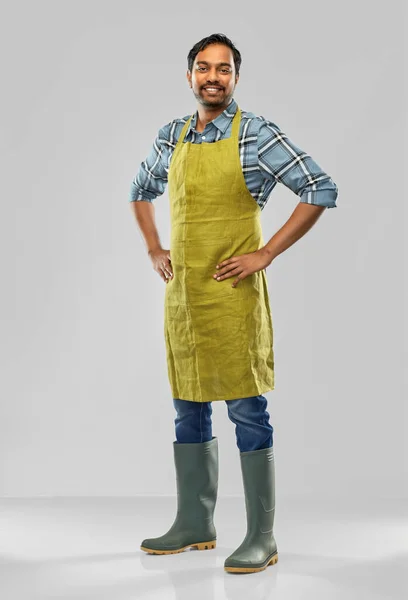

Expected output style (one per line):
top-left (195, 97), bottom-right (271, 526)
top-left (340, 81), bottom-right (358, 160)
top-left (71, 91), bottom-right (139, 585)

top-left (0, 0), bottom-right (408, 498)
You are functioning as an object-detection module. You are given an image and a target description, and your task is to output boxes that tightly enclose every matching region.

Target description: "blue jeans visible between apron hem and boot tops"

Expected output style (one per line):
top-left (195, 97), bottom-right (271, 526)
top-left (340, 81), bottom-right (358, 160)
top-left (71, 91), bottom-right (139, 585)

top-left (173, 395), bottom-right (273, 452)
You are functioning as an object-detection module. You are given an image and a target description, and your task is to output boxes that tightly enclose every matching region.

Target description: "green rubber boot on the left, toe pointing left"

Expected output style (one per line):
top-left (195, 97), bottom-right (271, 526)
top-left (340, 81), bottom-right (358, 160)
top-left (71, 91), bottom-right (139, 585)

top-left (140, 437), bottom-right (218, 554)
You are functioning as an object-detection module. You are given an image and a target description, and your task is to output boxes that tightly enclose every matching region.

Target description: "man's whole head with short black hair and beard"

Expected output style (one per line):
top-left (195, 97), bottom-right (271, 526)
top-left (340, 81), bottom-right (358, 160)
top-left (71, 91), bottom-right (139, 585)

top-left (187, 33), bottom-right (241, 108)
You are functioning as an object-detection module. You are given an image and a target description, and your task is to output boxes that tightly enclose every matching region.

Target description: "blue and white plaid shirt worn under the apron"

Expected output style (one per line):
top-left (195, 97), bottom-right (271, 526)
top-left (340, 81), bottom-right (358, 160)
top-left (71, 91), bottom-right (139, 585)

top-left (128, 99), bottom-right (338, 210)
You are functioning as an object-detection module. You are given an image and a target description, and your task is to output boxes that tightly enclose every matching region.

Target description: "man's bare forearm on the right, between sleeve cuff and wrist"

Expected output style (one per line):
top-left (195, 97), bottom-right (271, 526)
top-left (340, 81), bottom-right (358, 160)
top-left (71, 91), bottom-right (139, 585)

top-left (263, 202), bottom-right (325, 262)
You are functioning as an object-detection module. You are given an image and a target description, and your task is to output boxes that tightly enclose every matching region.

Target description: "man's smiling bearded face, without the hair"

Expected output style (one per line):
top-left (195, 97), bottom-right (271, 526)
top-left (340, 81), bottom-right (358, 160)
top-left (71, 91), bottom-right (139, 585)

top-left (187, 44), bottom-right (239, 107)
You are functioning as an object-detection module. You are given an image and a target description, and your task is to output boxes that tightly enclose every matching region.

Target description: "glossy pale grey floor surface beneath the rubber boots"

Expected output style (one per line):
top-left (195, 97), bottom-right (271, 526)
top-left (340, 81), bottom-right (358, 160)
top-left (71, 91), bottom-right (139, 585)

top-left (0, 497), bottom-right (408, 600)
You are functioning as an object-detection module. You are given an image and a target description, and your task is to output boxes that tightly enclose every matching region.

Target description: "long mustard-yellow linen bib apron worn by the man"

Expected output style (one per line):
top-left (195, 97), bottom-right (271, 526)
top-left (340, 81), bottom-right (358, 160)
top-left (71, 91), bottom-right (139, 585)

top-left (164, 108), bottom-right (274, 402)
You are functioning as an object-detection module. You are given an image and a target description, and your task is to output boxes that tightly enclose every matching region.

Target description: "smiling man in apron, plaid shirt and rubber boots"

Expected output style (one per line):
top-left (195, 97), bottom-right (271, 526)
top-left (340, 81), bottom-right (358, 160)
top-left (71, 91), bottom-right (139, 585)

top-left (129, 34), bottom-right (337, 573)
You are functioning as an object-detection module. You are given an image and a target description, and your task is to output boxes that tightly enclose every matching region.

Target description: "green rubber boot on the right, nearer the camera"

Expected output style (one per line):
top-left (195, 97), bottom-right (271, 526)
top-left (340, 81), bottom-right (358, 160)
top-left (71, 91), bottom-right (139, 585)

top-left (224, 447), bottom-right (278, 573)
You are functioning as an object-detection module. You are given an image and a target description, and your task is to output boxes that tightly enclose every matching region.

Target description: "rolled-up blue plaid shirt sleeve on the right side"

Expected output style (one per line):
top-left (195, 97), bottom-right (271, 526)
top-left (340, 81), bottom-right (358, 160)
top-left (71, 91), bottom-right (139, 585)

top-left (258, 120), bottom-right (338, 208)
